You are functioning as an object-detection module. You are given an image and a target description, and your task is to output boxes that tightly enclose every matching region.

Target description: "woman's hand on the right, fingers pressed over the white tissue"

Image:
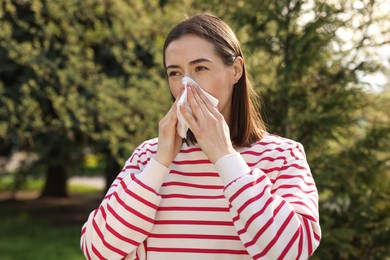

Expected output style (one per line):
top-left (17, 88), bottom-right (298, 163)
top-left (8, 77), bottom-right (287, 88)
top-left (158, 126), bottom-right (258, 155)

top-left (180, 86), bottom-right (236, 163)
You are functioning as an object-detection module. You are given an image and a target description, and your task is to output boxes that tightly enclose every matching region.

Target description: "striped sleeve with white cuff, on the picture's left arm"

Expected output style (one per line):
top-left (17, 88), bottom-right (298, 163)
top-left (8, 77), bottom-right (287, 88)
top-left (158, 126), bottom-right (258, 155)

top-left (80, 144), bottom-right (169, 259)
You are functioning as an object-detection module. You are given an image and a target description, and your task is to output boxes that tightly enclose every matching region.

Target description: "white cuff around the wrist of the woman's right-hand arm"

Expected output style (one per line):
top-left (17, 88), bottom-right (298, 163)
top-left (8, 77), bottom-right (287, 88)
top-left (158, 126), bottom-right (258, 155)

top-left (214, 153), bottom-right (251, 186)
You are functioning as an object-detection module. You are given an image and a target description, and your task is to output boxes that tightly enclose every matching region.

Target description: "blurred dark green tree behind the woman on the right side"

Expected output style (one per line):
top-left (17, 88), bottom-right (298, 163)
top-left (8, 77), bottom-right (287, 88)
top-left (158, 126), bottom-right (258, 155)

top-left (187, 0), bottom-right (390, 259)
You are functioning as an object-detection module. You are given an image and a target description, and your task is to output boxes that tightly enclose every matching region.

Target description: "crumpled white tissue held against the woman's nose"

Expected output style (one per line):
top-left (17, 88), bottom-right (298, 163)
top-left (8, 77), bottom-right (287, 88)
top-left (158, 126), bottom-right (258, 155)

top-left (177, 76), bottom-right (219, 138)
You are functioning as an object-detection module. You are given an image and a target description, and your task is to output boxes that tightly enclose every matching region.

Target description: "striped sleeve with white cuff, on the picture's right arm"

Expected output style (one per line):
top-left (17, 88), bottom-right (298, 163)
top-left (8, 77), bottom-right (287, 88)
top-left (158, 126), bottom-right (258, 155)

top-left (215, 144), bottom-right (321, 259)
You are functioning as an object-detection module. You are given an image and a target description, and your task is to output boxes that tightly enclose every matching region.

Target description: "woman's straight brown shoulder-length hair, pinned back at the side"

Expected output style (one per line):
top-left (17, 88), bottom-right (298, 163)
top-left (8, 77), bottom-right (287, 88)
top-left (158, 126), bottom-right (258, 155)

top-left (163, 14), bottom-right (265, 146)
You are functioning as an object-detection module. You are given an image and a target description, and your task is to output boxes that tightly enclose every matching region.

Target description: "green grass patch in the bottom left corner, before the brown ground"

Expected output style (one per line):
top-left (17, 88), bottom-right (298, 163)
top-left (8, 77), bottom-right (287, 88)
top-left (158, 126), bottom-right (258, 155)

top-left (0, 205), bottom-right (85, 260)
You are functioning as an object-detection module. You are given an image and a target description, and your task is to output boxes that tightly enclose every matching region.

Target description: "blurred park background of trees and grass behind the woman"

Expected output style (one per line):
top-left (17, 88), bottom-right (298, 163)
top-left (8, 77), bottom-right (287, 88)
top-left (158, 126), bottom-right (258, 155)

top-left (0, 0), bottom-right (390, 260)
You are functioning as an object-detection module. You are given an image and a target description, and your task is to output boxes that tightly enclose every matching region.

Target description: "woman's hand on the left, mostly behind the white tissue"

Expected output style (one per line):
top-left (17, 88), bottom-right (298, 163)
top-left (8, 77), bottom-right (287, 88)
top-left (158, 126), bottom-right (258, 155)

top-left (156, 98), bottom-right (183, 167)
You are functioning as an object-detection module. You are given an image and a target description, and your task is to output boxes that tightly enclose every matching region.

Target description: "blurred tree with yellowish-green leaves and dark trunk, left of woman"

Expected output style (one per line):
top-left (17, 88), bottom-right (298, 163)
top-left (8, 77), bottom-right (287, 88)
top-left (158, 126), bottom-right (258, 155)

top-left (0, 0), bottom-right (174, 196)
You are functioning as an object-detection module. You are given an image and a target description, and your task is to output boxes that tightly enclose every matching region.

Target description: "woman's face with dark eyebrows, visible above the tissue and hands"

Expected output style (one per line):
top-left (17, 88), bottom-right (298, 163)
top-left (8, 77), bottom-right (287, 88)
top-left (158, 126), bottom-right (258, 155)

top-left (165, 34), bottom-right (242, 120)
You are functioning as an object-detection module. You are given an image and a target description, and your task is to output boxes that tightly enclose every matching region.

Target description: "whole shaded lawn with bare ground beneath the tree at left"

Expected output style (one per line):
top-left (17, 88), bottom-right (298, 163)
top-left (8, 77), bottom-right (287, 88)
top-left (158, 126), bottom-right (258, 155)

top-left (0, 179), bottom-right (101, 260)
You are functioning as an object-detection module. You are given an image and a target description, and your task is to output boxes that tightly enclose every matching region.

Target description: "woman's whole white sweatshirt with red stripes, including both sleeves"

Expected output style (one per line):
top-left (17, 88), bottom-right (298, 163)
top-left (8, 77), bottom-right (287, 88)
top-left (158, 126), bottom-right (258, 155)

top-left (81, 134), bottom-right (321, 260)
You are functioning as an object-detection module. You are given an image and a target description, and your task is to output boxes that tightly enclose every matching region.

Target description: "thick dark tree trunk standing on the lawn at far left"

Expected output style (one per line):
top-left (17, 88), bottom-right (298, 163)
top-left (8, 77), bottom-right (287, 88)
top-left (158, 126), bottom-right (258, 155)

top-left (41, 165), bottom-right (68, 198)
